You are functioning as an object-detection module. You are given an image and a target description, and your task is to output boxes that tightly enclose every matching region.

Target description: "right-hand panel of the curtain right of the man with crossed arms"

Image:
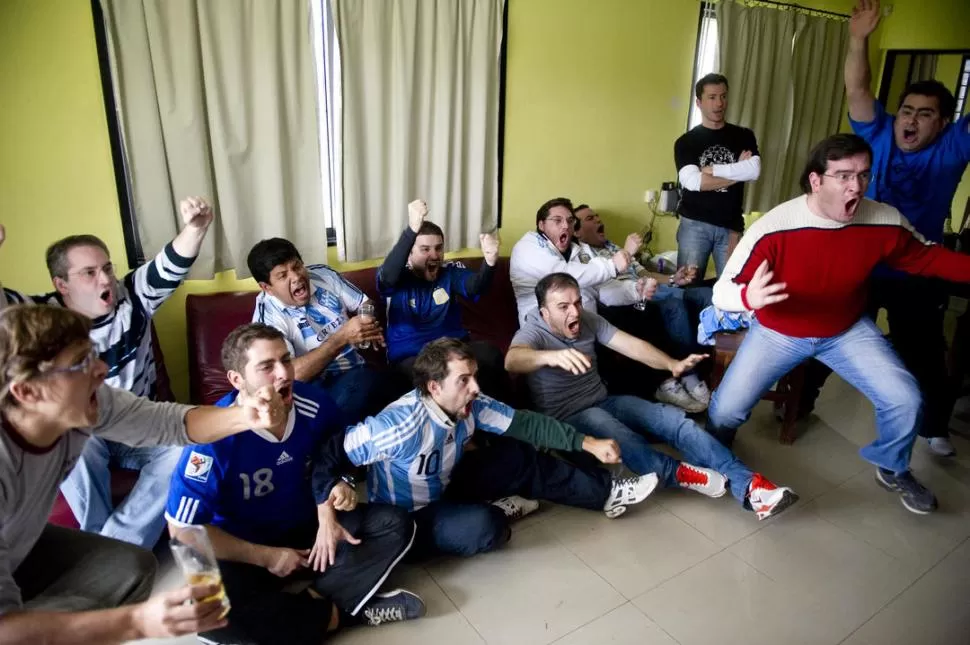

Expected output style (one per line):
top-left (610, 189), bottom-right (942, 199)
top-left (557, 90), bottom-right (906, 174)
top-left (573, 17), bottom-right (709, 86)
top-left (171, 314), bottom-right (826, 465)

top-left (779, 14), bottom-right (849, 201)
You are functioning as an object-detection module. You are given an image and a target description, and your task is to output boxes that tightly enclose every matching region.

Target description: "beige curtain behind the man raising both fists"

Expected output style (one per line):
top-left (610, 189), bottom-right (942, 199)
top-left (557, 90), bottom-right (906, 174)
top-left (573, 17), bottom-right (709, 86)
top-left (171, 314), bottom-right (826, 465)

top-left (333, 0), bottom-right (503, 261)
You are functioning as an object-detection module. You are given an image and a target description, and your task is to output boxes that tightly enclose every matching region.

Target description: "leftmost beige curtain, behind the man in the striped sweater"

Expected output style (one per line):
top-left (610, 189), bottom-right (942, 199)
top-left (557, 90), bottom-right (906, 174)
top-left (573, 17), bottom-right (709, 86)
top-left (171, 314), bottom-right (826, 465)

top-left (101, 0), bottom-right (326, 278)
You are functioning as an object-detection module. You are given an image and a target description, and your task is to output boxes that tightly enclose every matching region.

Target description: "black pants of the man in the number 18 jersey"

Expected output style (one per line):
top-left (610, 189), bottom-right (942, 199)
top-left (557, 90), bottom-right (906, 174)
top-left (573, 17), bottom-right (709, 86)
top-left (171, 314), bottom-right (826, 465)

top-left (203, 504), bottom-right (415, 645)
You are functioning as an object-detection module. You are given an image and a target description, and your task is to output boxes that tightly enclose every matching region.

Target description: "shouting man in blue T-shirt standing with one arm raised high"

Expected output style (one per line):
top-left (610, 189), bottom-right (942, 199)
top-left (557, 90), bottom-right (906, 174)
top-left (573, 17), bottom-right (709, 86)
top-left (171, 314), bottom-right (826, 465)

top-left (799, 0), bottom-right (970, 456)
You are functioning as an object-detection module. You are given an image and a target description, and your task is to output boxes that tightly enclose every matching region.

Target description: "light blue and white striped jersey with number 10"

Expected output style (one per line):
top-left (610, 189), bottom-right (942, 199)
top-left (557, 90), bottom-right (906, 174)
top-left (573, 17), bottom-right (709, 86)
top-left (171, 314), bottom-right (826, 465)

top-left (344, 390), bottom-right (515, 511)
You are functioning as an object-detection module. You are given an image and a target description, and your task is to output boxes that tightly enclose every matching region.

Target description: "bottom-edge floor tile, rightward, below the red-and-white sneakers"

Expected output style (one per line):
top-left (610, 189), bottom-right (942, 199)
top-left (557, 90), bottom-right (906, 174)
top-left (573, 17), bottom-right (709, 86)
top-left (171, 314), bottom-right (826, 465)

top-left (633, 551), bottom-right (862, 645)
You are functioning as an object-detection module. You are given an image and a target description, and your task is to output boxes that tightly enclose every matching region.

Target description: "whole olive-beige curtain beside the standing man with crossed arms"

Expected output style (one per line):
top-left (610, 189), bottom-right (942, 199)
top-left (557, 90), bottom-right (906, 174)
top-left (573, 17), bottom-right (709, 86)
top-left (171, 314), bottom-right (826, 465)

top-left (715, 0), bottom-right (848, 212)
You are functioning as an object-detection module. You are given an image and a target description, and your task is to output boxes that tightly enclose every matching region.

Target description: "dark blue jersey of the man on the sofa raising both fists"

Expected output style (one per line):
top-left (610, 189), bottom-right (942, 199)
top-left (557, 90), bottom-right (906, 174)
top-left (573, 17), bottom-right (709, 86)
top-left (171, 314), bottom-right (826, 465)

top-left (378, 262), bottom-right (477, 363)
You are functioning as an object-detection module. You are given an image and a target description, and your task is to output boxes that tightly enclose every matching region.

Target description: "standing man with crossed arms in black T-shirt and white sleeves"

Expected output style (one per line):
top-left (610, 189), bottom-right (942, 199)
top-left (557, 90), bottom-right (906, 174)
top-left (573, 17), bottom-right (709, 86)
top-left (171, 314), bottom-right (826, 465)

top-left (674, 74), bottom-right (761, 280)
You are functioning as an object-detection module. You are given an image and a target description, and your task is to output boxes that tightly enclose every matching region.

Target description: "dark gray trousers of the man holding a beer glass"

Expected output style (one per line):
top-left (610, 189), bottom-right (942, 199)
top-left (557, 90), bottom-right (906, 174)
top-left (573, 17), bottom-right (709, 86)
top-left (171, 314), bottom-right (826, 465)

top-left (13, 524), bottom-right (158, 611)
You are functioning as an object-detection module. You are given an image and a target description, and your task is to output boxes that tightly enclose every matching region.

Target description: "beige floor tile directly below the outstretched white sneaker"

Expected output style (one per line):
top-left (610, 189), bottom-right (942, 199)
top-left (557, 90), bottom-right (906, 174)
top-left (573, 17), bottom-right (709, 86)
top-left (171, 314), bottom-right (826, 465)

top-left (546, 500), bottom-right (720, 598)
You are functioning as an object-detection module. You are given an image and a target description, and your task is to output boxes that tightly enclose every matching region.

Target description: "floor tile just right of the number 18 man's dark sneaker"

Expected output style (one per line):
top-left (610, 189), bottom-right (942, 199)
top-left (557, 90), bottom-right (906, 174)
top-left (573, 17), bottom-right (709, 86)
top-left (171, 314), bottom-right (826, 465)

top-left (429, 524), bottom-right (632, 645)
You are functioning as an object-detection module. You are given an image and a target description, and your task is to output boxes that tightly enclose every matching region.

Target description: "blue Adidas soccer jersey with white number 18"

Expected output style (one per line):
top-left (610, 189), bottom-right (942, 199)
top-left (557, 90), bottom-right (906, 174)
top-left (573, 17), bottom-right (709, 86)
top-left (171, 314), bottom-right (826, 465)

top-left (165, 382), bottom-right (343, 544)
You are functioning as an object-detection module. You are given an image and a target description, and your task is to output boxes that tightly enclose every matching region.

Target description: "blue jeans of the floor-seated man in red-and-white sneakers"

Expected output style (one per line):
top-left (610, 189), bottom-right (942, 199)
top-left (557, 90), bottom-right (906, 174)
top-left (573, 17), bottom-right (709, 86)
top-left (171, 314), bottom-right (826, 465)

top-left (563, 396), bottom-right (753, 504)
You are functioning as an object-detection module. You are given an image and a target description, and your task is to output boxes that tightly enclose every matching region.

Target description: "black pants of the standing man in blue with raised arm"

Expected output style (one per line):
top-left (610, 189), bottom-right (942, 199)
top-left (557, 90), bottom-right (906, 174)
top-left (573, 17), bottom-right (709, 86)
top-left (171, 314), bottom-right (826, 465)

top-left (799, 276), bottom-right (956, 437)
